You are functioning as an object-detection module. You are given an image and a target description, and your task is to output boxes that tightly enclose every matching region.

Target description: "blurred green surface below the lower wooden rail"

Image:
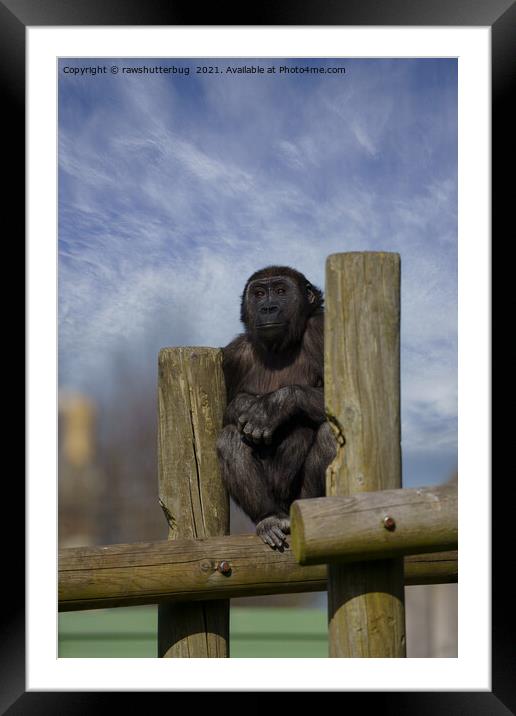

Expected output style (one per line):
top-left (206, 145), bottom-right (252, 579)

top-left (59, 606), bottom-right (328, 658)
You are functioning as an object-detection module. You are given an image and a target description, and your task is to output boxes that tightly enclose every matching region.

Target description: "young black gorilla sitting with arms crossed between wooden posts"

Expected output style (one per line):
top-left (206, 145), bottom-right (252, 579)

top-left (217, 266), bottom-right (335, 548)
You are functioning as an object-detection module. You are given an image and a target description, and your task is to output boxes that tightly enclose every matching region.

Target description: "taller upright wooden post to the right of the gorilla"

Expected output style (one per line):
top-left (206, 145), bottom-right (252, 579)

top-left (325, 252), bottom-right (406, 657)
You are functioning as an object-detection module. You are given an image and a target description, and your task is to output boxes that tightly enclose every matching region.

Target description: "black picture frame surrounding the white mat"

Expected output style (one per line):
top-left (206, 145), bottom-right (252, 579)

top-left (10, 0), bottom-right (510, 716)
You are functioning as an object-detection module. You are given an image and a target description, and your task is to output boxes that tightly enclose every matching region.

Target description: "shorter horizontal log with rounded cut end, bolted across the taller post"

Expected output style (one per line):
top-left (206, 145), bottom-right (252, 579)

top-left (290, 483), bottom-right (457, 565)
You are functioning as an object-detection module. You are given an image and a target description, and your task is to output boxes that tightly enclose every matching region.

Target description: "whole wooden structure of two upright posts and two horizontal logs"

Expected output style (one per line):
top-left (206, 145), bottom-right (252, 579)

top-left (59, 252), bottom-right (457, 657)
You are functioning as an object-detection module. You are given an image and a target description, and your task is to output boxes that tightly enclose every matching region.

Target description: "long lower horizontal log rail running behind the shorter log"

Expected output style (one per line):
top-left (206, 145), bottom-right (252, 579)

top-left (59, 535), bottom-right (457, 611)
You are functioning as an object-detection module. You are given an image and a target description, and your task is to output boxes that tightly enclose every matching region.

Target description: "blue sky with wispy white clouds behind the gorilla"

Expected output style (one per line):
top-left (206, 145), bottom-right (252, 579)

top-left (59, 58), bottom-right (457, 485)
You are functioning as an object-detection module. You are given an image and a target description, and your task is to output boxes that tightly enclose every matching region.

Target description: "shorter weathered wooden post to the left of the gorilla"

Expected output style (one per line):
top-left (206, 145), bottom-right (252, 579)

top-left (158, 348), bottom-right (229, 657)
